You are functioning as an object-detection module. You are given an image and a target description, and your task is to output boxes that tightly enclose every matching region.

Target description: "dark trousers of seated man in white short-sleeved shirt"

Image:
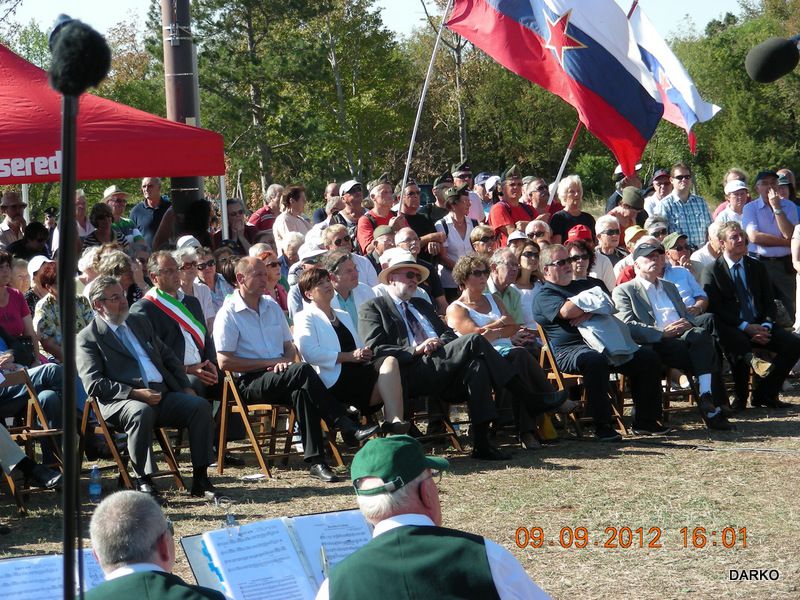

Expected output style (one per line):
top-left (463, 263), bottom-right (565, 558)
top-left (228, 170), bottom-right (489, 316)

top-left (240, 363), bottom-right (344, 463)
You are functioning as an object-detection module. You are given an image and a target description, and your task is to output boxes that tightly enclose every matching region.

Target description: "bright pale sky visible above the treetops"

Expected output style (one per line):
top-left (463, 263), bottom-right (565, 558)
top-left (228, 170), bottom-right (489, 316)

top-left (9, 0), bottom-right (739, 38)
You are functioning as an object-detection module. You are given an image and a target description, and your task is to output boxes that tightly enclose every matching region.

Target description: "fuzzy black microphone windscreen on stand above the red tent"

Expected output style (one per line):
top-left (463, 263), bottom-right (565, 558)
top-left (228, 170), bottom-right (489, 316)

top-left (49, 20), bottom-right (111, 96)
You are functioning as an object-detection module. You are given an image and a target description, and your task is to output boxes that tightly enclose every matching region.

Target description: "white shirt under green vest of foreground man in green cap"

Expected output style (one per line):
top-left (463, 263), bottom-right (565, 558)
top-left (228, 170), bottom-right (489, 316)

top-left (316, 514), bottom-right (550, 600)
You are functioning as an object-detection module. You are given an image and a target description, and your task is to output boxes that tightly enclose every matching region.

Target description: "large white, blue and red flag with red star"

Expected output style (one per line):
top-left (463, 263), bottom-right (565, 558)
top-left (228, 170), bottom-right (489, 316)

top-left (447, 0), bottom-right (663, 175)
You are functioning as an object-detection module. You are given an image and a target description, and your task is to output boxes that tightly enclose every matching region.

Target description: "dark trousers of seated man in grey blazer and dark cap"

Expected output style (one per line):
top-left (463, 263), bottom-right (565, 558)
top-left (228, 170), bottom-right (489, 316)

top-left (653, 327), bottom-right (728, 406)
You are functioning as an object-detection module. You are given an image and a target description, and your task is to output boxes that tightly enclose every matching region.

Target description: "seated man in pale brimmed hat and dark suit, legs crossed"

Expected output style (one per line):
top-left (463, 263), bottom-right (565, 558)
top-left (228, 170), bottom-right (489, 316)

top-left (358, 252), bottom-right (564, 460)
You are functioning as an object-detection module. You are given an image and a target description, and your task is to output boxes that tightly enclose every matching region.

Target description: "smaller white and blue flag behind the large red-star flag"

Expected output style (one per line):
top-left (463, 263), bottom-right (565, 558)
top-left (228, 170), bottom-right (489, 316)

top-left (630, 6), bottom-right (720, 154)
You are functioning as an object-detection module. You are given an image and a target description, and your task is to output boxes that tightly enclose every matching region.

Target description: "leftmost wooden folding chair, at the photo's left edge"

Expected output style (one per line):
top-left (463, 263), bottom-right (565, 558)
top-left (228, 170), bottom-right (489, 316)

top-left (0, 370), bottom-right (62, 515)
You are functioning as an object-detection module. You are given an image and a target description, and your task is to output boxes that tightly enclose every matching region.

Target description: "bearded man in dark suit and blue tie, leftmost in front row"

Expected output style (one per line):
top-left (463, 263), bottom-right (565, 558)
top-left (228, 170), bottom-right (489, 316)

top-left (77, 276), bottom-right (216, 499)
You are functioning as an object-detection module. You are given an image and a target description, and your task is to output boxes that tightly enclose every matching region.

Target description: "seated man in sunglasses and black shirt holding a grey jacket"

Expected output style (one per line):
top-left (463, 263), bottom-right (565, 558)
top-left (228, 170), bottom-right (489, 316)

top-left (533, 244), bottom-right (669, 442)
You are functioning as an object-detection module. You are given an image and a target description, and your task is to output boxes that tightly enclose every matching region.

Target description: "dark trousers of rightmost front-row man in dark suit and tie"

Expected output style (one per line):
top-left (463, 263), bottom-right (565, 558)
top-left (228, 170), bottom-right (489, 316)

top-left (717, 320), bottom-right (800, 402)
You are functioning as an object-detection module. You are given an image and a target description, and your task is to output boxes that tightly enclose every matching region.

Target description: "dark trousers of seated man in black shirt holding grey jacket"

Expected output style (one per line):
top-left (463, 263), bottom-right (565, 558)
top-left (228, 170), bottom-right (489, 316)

top-left (556, 345), bottom-right (662, 425)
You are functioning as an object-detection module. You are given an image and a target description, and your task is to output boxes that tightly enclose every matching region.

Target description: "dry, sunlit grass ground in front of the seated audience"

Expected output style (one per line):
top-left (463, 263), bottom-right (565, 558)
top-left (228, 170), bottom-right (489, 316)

top-left (0, 392), bottom-right (800, 599)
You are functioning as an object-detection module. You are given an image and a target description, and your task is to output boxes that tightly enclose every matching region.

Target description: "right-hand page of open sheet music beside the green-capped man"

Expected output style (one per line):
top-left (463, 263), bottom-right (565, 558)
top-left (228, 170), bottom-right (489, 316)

top-left (287, 510), bottom-right (372, 587)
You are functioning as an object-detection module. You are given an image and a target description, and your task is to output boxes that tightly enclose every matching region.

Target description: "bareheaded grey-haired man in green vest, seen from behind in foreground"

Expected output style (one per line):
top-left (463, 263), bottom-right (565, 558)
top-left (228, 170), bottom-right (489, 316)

top-left (85, 491), bottom-right (224, 600)
